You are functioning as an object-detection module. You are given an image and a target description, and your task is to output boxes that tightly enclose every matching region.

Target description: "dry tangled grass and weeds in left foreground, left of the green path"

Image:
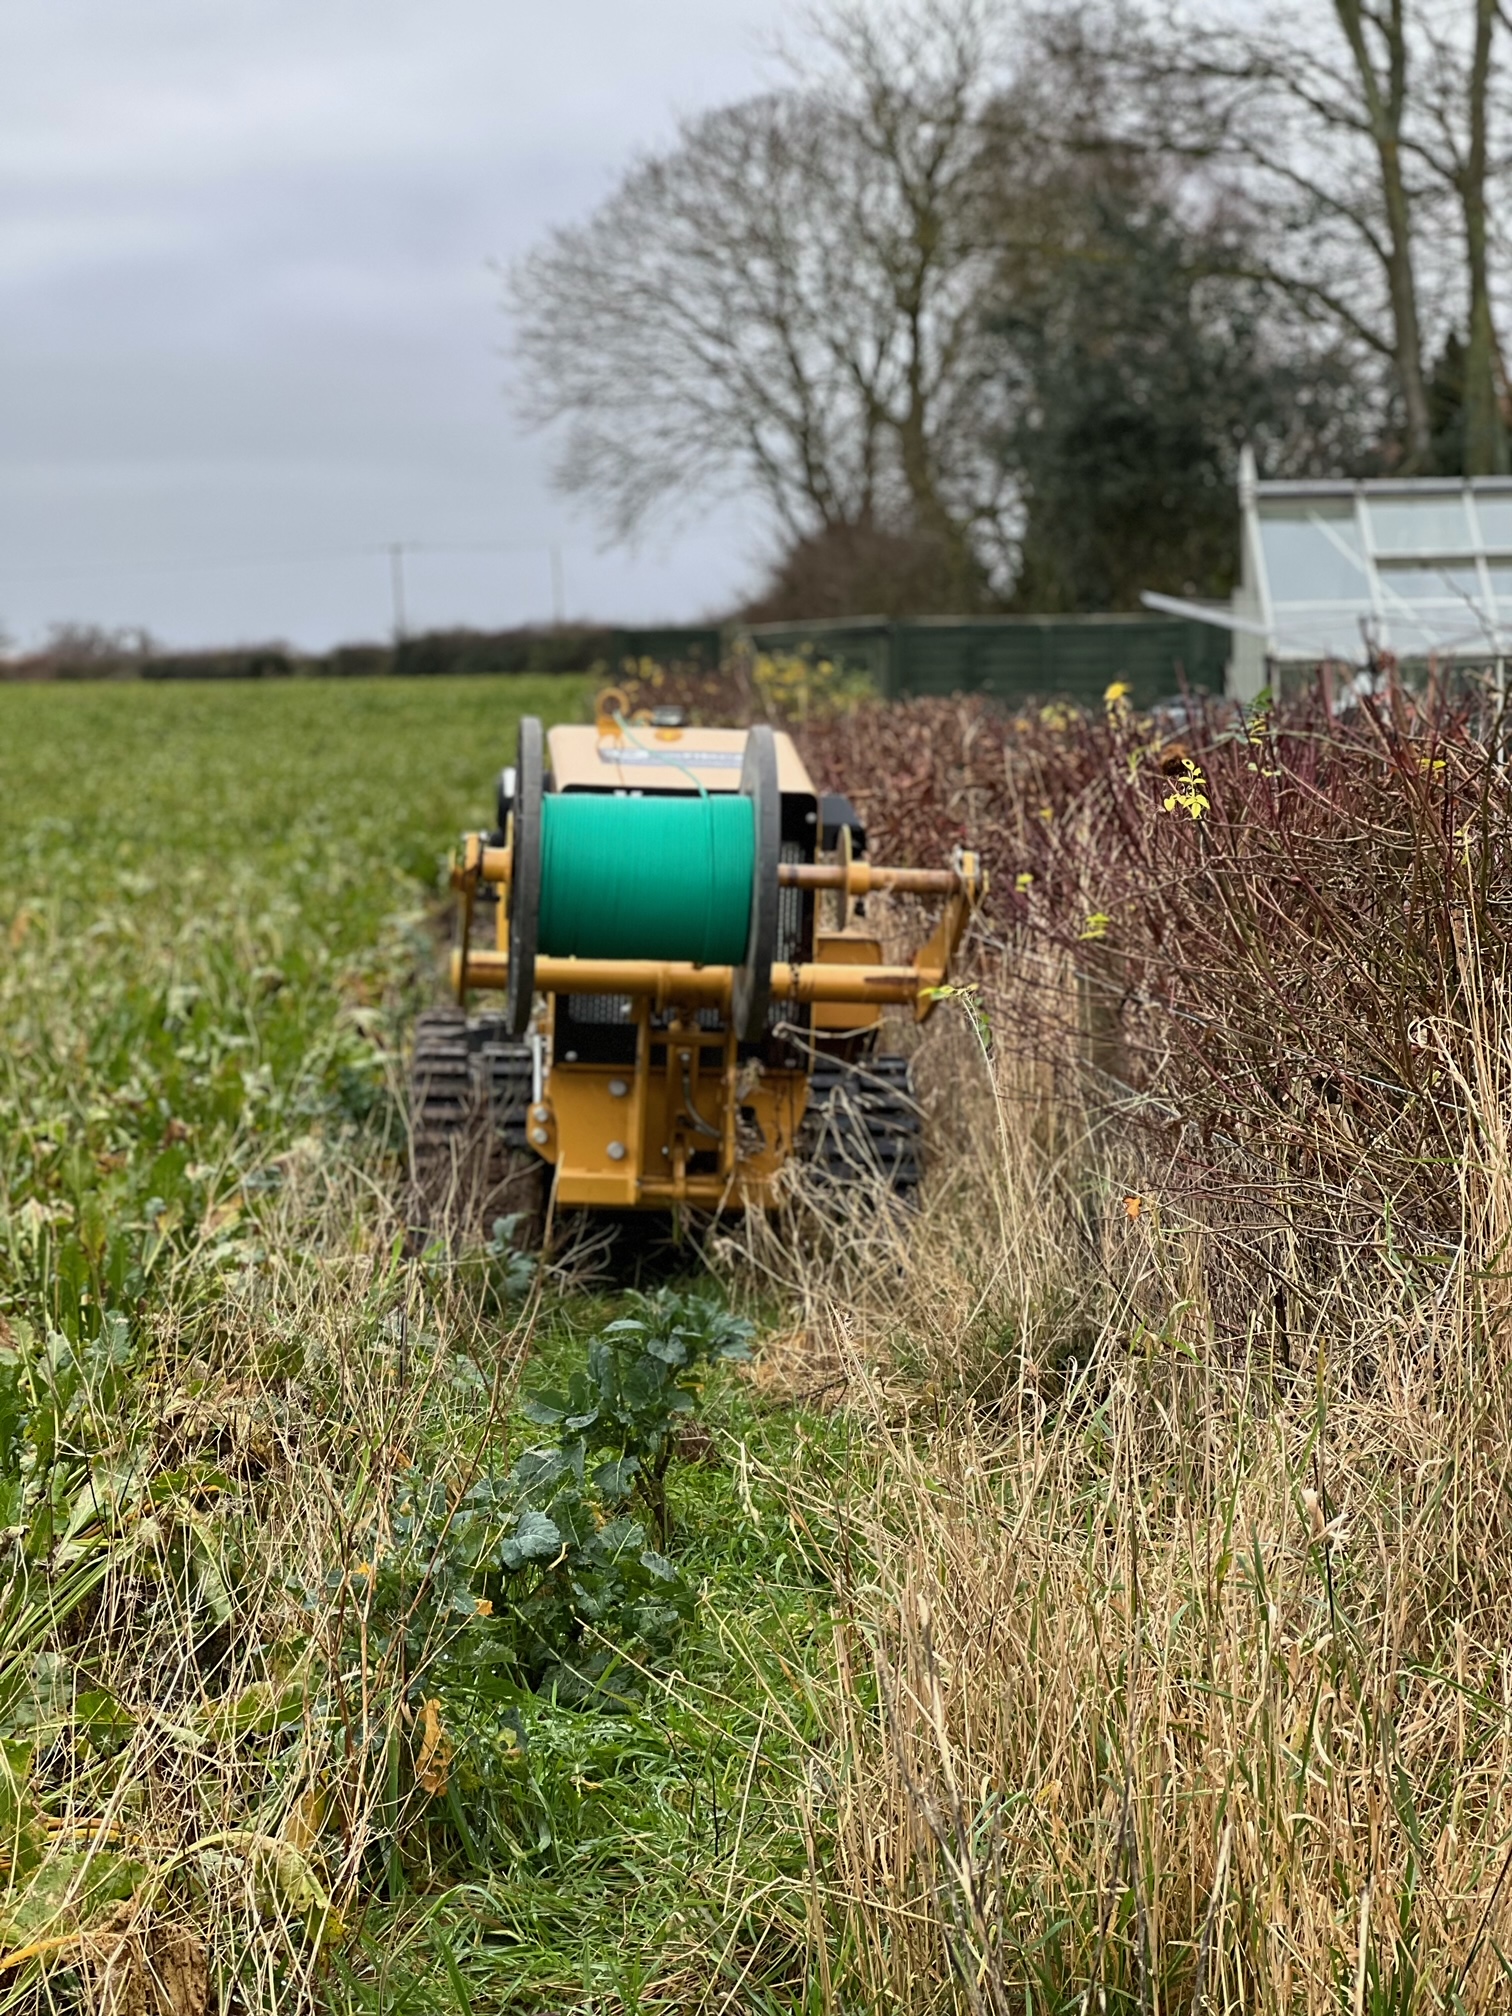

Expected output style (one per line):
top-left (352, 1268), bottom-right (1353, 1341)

top-left (0, 1155), bottom-right (530, 2016)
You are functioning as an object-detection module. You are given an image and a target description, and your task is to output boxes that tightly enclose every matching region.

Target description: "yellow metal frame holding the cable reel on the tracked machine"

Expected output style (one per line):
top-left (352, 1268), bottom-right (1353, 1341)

top-left (452, 818), bottom-right (986, 1210)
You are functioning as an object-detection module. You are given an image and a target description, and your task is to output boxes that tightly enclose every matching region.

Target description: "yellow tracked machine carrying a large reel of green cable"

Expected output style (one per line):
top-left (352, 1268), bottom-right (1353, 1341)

top-left (411, 694), bottom-right (984, 1212)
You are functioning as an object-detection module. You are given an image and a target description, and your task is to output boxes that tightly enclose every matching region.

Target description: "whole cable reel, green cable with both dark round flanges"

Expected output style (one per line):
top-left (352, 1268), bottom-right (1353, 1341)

top-left (506, 716), bottom-right (782, 1042)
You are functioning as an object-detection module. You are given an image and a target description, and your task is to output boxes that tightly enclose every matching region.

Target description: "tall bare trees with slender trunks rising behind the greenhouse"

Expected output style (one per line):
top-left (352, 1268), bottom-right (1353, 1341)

top-left (1060, 0), bottom-right (1506, 474)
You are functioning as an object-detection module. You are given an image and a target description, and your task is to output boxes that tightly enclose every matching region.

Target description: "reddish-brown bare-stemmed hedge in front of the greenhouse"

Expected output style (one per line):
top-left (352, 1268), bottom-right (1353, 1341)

top-left (806, 685), bottom-right (1512, 1349)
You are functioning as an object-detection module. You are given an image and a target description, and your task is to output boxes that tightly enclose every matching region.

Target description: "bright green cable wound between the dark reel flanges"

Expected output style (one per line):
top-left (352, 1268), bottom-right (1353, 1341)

top-left (538, 792), bottom-right (756, 966)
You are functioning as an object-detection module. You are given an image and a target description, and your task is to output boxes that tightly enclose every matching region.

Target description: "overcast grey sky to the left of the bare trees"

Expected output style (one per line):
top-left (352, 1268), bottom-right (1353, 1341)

top-left (0, 0), bottom-right (806, 645)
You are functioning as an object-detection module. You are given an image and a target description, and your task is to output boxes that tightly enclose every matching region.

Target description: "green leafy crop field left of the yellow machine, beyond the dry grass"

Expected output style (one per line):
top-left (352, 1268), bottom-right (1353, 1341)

top-left (0, 679), bottom-right (581, 1325)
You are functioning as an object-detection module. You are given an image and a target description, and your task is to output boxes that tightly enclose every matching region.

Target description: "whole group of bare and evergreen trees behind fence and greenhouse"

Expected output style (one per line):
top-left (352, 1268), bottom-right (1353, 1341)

top-left (510, 0), bottom-right (1512, 617)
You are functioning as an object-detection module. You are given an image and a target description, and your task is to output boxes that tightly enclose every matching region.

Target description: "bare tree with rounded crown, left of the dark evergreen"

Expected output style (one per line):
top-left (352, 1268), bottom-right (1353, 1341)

top-left (512, 0), bottom-right (1020, 592)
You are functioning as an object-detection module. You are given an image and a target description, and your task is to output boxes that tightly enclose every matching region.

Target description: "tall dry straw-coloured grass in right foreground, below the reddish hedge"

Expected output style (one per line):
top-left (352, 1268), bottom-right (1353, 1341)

top-left (741, 960), bottom-right (1512, 2016)
